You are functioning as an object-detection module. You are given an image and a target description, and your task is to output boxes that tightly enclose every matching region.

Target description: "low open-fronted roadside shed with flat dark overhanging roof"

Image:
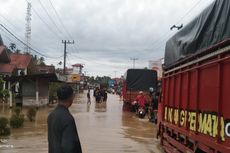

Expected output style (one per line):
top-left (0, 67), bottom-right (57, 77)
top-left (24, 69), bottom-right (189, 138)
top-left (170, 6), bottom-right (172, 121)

top-left (5, 73), bottom-right (63, 107)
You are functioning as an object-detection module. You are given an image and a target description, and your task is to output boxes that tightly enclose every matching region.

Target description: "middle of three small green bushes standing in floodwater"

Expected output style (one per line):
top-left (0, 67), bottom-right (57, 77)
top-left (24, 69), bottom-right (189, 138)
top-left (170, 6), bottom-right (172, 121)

top-left (10, 107), bottom-right (24, 128)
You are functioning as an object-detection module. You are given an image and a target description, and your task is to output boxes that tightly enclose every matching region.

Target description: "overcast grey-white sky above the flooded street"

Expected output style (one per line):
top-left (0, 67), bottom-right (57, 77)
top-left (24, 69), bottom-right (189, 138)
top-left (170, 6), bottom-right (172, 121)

top-left (0, 0), bottom-right (214, 77)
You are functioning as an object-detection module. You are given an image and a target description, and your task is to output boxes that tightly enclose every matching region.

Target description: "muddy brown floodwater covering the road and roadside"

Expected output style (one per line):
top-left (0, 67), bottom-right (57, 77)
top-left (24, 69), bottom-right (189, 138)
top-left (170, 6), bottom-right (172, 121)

top-left (0, 93), bottom-right (162, 153)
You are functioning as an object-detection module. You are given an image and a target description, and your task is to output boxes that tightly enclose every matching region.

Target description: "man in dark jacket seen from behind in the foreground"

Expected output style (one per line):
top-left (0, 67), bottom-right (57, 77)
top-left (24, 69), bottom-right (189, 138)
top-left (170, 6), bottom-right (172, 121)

top-left (48, 85), bottom-right (82, 153)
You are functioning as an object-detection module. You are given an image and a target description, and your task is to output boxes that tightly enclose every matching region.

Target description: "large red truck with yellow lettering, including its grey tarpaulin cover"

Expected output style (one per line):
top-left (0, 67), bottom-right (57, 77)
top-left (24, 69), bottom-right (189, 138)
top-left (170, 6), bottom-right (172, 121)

top-left (158, 0), bottom-right (230, 153)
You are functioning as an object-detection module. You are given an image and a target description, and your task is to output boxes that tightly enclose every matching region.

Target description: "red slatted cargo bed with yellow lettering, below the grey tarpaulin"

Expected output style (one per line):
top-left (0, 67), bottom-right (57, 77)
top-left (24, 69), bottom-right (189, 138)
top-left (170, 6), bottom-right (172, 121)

top-left (158, 39), bottom-right (230, 153)
